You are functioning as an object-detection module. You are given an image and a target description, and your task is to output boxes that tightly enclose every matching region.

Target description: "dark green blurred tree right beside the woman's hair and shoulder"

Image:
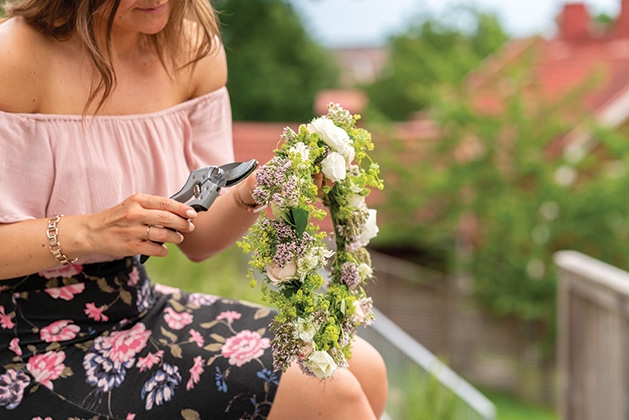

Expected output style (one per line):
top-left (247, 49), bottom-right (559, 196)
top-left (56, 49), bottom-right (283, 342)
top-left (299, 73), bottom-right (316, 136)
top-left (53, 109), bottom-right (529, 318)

top-left (215, 0), bottom-right (339, 121)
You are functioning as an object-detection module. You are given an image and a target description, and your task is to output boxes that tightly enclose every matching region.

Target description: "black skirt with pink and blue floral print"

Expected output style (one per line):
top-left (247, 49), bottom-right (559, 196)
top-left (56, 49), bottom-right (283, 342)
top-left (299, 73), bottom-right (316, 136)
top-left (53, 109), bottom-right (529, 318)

top-left (0, 258), bottom-right (281, 420)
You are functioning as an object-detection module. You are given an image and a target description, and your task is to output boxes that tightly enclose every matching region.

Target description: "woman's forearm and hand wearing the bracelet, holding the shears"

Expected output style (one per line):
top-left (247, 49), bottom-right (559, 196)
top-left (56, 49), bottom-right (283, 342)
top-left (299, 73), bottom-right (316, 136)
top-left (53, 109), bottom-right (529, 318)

top-left (0, 194), bottom-right (196, 280)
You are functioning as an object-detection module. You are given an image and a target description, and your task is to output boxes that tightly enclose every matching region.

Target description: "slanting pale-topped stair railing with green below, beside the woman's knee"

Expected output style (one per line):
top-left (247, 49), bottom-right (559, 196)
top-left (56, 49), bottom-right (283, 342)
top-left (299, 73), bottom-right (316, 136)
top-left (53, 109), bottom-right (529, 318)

top-left (359, 311), bottom-right (495, 420)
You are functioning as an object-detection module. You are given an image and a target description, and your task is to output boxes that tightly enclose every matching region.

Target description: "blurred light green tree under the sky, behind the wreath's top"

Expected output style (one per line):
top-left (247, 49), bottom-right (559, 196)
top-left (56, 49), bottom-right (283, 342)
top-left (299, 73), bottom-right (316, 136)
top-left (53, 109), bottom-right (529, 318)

top-left (365, 8), bottom-right (507, 121)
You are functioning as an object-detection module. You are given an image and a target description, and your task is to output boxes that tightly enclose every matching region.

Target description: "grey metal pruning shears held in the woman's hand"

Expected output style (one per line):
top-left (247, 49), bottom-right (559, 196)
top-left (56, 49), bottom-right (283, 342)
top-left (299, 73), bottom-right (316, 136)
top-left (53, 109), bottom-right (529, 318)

top-left (140, 159), bottom-right (258, 264)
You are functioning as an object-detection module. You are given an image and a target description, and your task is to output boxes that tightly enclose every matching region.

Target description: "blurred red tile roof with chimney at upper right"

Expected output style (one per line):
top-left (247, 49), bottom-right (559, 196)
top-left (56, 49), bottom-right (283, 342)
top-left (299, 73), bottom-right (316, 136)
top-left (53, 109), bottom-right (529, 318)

top-left (469, 0), bottom-right (629, 153)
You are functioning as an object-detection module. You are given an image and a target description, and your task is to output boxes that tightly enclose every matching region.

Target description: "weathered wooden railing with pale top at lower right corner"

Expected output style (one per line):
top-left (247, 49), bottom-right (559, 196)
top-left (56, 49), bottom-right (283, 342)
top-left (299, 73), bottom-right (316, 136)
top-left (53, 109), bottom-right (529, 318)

top-left (555, 251), bottom-right (629, 420)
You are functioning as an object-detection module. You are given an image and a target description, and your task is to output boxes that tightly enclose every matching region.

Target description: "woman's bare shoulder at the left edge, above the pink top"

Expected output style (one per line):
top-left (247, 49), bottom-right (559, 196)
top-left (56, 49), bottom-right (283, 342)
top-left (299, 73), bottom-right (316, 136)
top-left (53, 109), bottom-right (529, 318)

top-left (0, 18), bottom-right (49, 112)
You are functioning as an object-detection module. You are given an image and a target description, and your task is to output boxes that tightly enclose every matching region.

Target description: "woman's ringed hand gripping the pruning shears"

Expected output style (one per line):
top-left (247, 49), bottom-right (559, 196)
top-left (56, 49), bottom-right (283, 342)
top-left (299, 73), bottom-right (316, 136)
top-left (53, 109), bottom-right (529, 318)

top-left (85, 194), bottom-right (197, 257)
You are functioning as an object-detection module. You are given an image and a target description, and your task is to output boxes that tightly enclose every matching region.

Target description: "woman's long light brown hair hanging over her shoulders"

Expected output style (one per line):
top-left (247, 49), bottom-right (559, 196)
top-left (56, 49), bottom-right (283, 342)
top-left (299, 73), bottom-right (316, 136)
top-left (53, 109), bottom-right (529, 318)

top-left (4, 0), bottom-right (220, 112)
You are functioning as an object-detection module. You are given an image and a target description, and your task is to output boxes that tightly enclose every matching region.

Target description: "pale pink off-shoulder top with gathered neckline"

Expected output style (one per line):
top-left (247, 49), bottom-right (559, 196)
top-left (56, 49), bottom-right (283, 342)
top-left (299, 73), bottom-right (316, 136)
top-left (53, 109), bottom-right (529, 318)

top-left (0, 87), bottom-right (234, 262)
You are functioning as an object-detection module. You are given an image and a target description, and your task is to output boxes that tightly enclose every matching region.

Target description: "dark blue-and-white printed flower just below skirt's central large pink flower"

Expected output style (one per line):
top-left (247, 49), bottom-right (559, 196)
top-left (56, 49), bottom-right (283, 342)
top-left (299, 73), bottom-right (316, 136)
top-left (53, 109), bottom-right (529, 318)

top-left (83, 351), bottom-right (135, 392)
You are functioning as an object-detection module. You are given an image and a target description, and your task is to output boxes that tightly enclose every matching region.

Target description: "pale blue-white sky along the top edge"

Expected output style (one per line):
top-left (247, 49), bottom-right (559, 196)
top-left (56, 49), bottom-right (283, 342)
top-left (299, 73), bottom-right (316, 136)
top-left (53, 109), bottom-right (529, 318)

top-left (291, 0), bottom-right (621, 48)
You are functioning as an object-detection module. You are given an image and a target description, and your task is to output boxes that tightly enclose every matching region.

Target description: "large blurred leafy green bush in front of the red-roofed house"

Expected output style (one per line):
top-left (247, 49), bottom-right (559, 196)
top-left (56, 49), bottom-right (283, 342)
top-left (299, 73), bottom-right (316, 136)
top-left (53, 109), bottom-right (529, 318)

top-left (377, 55), bottom-right (629, 338)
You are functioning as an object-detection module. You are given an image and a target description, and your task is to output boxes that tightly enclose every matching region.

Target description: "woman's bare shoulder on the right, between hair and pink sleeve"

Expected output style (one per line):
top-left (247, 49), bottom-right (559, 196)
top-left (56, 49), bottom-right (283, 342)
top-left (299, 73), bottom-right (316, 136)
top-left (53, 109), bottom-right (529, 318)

top-left (192, 33), bottom-right (227, 97)
